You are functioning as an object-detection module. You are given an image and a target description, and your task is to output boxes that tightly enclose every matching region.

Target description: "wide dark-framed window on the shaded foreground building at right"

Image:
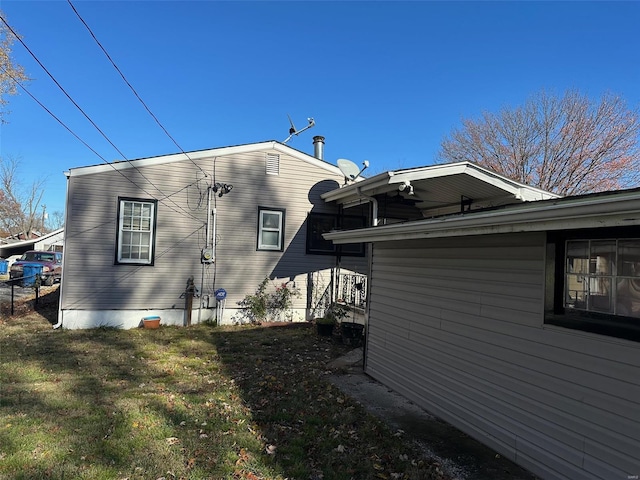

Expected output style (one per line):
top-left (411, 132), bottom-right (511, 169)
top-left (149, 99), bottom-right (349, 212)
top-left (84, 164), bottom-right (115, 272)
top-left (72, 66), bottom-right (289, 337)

top-left (546, 229), bottom-right (640, 341)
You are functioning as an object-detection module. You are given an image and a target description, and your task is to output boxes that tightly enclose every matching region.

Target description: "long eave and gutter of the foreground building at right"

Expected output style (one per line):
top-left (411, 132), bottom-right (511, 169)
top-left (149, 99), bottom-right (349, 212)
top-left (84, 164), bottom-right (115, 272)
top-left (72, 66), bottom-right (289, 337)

top-left (324, 188), bottom-right (640, 244)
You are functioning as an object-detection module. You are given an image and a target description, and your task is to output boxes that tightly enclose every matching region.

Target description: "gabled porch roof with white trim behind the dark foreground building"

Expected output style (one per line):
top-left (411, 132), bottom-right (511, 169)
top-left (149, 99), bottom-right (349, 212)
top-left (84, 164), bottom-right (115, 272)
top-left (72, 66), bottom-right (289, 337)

top-left (322, 162), bottom-right (559, 216)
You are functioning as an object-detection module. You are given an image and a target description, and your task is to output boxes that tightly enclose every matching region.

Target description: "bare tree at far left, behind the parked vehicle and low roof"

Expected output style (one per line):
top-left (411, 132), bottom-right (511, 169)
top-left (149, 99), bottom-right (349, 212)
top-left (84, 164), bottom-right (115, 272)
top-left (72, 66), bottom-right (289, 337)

top-left (0, 157), bottom-right (45, 238)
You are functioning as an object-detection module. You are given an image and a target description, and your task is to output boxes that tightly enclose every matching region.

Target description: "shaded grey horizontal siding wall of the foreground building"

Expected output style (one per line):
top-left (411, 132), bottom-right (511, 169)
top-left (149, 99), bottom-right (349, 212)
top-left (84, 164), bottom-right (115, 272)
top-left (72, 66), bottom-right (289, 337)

top-left (365, 233), bottom-right (640, 480)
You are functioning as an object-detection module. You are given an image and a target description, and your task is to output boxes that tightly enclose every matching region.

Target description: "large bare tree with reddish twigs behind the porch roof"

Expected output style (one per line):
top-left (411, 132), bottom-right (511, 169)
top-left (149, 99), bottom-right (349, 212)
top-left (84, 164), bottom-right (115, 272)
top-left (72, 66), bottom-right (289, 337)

top-left (438, 91), bottom-right (640, 195)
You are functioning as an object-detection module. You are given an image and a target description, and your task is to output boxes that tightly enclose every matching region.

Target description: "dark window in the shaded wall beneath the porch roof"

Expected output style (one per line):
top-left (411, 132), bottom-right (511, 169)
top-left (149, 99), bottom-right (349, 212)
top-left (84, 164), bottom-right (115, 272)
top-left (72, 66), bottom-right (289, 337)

top-left (307, 213), bottom-right (366, 257)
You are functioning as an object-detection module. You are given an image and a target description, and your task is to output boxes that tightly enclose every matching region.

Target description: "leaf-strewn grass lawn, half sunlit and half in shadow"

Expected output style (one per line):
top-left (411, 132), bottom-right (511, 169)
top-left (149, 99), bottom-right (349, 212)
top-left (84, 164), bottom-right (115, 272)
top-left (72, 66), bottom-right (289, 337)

top-left (0, 291), bottom-right (444, 480)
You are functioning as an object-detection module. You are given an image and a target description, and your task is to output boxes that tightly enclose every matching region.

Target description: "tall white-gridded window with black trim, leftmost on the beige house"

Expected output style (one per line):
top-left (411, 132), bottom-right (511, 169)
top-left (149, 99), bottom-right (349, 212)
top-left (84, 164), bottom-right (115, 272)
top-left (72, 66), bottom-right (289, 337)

top-left (116, 198), bottom-right (157, 265)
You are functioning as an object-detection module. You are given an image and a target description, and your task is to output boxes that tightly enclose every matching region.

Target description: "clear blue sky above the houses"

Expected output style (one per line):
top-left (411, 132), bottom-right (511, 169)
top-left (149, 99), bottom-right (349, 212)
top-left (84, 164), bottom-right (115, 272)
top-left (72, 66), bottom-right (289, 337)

top-left (0, 0), bottom-right (640, 219)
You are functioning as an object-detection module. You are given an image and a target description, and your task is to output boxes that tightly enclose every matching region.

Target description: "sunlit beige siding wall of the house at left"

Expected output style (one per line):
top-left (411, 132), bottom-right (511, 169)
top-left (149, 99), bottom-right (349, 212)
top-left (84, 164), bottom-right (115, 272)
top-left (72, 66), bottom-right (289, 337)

top-left (61, 150), bottom-right (364, 328)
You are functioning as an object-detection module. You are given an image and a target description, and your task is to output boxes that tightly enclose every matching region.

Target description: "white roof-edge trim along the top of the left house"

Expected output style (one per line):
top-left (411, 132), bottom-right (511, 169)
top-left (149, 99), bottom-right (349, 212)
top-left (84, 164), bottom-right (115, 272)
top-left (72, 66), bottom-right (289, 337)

top-left (65, 140), bottom-right (342, 177)
